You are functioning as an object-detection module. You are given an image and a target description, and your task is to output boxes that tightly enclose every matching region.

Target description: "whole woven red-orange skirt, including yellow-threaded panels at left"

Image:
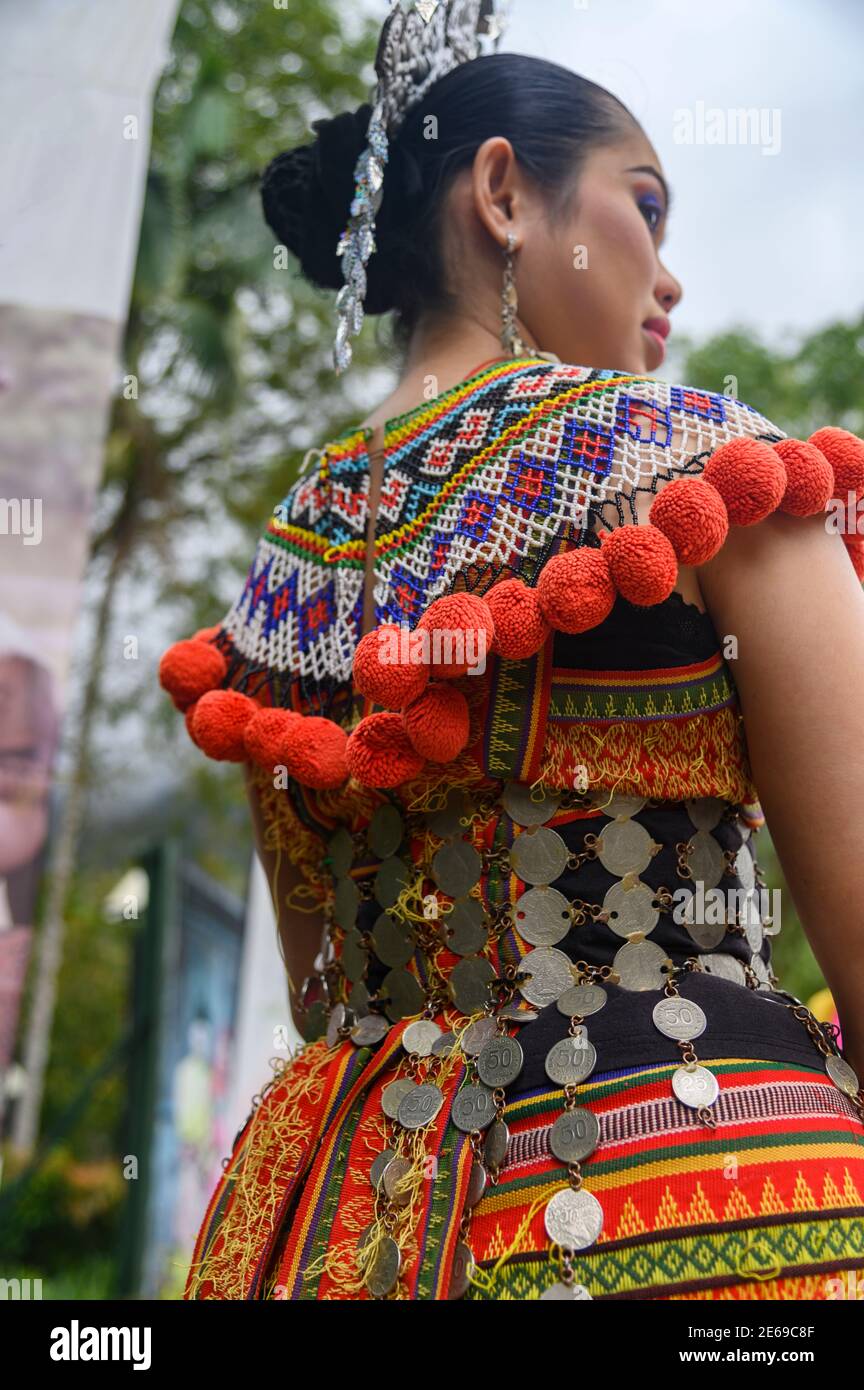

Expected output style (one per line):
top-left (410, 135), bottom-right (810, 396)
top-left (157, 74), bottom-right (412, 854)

top-left (186, 1045), bottom-right (864, 1301)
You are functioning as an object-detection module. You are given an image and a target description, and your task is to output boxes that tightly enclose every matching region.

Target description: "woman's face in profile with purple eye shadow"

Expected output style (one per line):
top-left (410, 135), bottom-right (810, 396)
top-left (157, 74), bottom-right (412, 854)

top-left (514, 128), bottom-right (682, 375)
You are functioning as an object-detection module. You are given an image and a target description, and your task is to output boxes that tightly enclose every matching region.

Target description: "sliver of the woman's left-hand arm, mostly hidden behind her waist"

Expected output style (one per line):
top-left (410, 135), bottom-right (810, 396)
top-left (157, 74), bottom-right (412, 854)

top-left (244, 763), bottom-right (331, 1031)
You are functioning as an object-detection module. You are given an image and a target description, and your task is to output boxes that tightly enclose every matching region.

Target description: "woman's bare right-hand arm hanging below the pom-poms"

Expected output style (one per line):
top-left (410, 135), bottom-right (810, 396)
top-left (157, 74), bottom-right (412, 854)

top-left (699, 512), bottom-right (864, 1081)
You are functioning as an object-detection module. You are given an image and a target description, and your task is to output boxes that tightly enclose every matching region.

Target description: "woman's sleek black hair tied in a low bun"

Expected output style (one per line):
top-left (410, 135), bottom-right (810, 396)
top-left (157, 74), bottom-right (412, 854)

top-left (261, 53), bottom-right (638, 345)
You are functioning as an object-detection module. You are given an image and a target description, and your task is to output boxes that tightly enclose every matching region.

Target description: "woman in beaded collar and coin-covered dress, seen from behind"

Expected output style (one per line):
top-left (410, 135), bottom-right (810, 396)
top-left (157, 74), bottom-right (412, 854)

top-left (161, 7), bottom-right (864, 1300)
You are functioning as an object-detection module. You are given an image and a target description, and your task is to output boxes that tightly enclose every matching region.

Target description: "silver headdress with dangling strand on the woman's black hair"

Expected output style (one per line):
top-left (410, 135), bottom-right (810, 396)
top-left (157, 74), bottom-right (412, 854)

top-left (333, 0), bottom-right (503, 374)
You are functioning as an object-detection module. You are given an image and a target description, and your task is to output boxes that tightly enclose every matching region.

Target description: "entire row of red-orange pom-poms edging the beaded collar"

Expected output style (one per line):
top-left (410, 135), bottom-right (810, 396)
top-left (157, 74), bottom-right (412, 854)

top-left (160, 428), bottom-right (864, 788)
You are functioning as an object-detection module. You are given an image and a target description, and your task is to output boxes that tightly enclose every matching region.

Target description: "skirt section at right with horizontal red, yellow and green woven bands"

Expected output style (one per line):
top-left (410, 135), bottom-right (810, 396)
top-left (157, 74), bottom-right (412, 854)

top-left (465, 1058), bottom-right (864, 1300)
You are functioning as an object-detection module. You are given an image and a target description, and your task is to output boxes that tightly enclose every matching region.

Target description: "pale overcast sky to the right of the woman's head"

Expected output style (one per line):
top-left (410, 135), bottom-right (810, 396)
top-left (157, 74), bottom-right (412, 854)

top-left (500, 0), bottom-right (864, 350)
